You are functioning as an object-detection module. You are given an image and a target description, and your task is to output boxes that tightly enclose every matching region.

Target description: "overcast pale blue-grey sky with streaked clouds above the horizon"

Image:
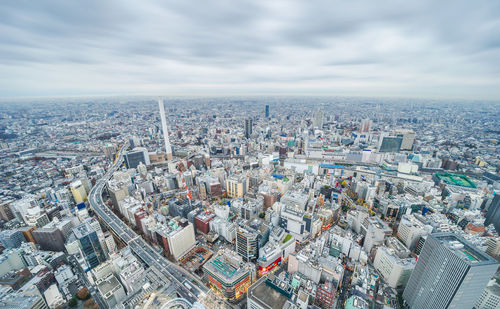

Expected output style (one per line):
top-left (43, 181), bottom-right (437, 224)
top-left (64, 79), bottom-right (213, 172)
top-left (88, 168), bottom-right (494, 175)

top-left (0, 0), bottom-right (500, 101)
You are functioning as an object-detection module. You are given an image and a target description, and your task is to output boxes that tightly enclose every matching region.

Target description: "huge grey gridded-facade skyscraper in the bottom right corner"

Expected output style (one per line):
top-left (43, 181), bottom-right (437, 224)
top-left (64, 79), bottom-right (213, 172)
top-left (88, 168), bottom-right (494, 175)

top-left (403, 233), bottom-right (498, 309)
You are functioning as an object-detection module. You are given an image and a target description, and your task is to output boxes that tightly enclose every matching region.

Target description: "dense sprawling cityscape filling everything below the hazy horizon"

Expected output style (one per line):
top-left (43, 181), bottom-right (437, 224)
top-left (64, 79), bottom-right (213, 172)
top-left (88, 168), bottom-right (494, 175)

top-left (0, 95), bottom-right (500, 309)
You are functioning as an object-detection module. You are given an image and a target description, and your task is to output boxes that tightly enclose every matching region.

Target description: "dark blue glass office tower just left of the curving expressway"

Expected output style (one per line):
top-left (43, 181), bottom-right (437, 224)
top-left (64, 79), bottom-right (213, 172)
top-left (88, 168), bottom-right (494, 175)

top-left (73, 221), bottom-right (106, 269)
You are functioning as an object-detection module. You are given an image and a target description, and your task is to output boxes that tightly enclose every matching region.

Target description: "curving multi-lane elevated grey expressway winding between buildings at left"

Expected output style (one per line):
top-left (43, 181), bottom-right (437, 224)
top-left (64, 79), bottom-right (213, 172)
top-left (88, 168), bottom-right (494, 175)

top-left (88, 143), bottom-right (209, 304)
